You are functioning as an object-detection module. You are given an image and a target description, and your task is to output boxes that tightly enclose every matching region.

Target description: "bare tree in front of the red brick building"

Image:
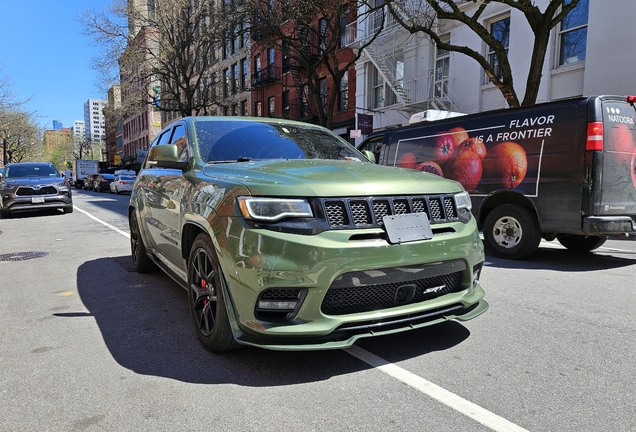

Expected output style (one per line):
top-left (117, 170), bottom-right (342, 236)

top-left (249, 0), bottom-right (384, 127)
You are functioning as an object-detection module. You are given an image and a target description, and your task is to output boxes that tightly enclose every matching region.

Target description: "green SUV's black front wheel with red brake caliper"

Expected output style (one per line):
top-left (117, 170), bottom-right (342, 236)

top-left (188, 234), bottom-right (239, 352)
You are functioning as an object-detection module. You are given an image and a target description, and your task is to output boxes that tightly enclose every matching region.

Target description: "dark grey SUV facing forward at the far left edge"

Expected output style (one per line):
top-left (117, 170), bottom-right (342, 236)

top-left (0, 162), bottom-right (73, 219)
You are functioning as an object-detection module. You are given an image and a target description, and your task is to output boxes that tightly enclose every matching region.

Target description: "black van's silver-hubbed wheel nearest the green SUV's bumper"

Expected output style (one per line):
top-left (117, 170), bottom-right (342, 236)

top-left (483, 204), bottom-right (541, 259)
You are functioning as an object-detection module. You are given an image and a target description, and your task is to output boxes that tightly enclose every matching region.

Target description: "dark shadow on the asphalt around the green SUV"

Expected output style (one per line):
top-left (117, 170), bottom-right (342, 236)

top-left (69, 256), bottom-right (470, 387)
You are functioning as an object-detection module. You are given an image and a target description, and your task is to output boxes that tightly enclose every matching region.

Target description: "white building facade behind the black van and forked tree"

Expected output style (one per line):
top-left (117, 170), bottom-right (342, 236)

top-left (351, 0), bottom-right (636, 141)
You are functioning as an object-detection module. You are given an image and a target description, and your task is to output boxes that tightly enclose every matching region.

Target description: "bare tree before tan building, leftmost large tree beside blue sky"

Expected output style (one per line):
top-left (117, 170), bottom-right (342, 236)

top-left (80, 0), bottom-right (241, 116)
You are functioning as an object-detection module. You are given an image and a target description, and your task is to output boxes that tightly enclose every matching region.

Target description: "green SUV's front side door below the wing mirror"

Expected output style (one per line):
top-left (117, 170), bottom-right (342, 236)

top-left (152, 123), bottom-right (191, 268)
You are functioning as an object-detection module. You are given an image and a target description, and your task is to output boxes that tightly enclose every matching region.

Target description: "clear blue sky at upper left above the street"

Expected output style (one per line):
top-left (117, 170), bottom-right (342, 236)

top-left (0, 0), bottom-right (111, 129)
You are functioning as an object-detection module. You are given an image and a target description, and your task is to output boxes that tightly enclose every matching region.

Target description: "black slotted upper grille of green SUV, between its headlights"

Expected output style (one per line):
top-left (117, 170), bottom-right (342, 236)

top-left (321, 195), bottom-right (459, 228)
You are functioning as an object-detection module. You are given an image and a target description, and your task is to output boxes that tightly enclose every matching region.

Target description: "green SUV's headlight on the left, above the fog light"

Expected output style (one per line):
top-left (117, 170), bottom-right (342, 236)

top-left (238, 197), bottom-right (314, 222)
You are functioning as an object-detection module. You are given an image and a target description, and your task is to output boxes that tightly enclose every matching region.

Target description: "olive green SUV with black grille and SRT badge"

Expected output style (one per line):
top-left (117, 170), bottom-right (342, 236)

top-left (129, 117), bottom-right (488, 351)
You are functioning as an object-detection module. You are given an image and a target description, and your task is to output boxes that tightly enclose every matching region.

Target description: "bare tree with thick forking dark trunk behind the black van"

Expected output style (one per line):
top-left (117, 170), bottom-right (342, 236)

top-left (386, 0), bottom-right (580, 107)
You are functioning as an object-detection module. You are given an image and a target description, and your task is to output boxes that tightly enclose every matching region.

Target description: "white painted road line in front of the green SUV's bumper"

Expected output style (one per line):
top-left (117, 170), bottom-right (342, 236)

top-left (344, 345), bottom-right (527, 432)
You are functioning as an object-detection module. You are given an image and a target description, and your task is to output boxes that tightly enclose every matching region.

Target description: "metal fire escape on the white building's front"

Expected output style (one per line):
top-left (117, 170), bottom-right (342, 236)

top-left (346, 8), bottom-right (458, 114)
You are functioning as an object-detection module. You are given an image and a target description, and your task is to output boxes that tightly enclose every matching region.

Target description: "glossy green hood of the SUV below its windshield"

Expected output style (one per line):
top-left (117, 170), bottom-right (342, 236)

top-left (203, 159), bottom-right (463, 197)
